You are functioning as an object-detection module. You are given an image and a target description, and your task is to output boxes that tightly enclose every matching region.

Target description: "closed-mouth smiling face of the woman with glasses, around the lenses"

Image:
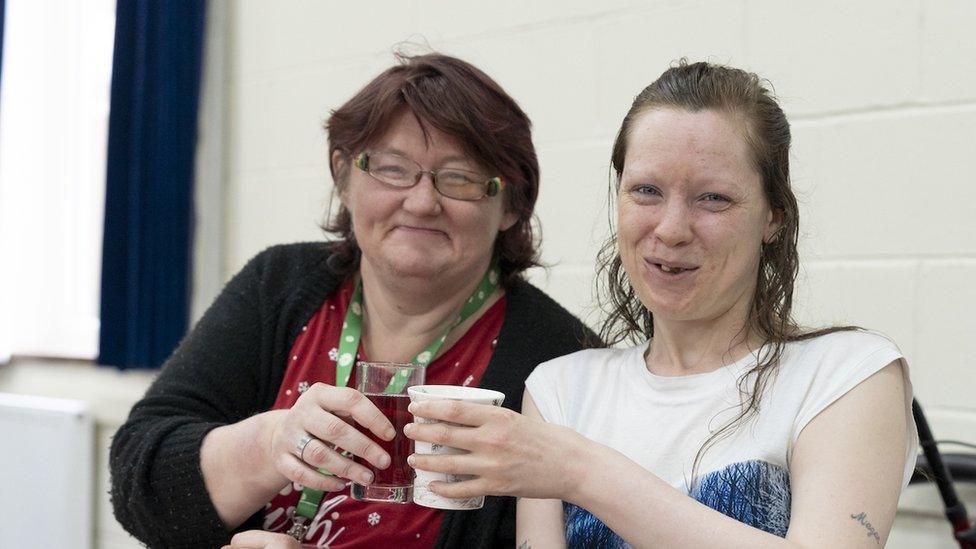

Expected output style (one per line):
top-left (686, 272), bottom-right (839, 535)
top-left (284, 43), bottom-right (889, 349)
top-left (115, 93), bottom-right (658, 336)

top-left (332, 111), bottom-right (516, 281)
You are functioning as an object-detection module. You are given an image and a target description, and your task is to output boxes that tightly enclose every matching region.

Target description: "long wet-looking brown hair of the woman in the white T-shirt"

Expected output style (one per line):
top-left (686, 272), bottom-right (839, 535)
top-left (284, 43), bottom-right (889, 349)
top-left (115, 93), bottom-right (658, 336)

top-left (597, 59), bottom-right (857, 479)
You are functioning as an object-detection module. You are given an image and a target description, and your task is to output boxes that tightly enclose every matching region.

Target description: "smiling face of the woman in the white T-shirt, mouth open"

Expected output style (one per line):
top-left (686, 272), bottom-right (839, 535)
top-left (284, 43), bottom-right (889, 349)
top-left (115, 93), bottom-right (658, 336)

top-left (617, 108), bottom-right (779, 328)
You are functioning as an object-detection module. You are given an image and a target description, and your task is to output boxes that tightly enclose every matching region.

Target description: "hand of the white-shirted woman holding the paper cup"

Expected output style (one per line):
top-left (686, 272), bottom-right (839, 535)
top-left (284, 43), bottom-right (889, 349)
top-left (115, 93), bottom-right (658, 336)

top-left (403, 400), bottom-right (594, 500)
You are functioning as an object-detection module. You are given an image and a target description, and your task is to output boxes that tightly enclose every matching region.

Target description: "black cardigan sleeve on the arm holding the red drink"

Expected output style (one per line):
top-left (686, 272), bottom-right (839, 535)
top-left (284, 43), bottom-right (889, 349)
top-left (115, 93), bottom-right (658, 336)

top-left (109, 252), bottom-right (276, 547)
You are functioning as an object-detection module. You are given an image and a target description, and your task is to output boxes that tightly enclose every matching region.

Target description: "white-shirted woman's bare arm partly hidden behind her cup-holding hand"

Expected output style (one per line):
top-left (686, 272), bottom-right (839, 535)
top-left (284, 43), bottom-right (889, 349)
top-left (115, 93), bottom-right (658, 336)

top-left (515, 390), bottom-right (566, 549)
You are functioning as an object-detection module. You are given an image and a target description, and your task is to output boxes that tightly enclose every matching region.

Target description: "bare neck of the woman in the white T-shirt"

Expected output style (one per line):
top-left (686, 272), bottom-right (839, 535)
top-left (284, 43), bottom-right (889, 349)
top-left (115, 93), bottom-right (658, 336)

top-left (644, 296), bottom-right (762, 376)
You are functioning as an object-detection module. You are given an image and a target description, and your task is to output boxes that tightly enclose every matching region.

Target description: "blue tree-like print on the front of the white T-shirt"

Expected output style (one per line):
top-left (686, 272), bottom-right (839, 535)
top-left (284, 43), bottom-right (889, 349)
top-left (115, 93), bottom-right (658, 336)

top-left (563, 459), bottom-right (791, 549)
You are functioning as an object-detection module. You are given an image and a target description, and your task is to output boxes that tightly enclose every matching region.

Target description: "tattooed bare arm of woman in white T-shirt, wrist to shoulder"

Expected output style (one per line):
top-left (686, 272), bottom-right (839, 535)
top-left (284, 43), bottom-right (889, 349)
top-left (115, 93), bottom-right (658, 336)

top-left (573, 362), bottom-right (907, 548)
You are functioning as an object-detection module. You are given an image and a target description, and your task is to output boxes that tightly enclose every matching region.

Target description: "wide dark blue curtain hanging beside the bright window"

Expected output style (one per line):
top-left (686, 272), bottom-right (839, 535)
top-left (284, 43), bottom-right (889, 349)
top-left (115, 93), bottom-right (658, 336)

top-left (98, 0), bottom-right (205, 369)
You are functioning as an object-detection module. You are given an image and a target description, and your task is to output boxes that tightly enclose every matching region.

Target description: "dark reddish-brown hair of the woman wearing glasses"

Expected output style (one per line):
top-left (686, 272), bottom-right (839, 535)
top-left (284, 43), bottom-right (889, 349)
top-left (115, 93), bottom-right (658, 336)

top-left (323, 53), bottom-right (539, 285)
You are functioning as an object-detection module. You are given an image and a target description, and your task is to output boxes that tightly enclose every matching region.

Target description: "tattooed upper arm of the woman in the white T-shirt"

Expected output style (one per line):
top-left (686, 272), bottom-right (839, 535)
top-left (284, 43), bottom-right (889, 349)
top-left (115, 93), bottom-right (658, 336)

top-left (786, 360), bottom-right (908, 547)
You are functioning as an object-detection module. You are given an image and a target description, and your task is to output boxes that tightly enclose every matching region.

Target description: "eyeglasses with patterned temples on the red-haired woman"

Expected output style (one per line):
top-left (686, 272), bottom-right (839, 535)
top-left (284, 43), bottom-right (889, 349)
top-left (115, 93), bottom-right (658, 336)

top-left (355, 151), bottom-right (505, 201)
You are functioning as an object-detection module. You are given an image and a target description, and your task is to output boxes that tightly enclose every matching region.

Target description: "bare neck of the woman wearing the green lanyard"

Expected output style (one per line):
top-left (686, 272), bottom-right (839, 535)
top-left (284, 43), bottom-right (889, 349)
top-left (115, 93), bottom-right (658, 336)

top-left (360, 260), bottom-right (499, 362)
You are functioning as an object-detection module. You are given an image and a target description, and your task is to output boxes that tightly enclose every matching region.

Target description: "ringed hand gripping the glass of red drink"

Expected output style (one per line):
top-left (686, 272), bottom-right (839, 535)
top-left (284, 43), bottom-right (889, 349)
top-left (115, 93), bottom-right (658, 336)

top-left (270, 383), bottom-right (395, 492)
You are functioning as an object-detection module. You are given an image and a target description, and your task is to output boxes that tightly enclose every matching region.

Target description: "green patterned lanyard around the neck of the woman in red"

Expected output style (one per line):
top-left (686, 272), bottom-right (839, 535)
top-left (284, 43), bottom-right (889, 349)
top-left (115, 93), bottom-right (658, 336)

top-left (288, 263), bottom-right (498, 541)
